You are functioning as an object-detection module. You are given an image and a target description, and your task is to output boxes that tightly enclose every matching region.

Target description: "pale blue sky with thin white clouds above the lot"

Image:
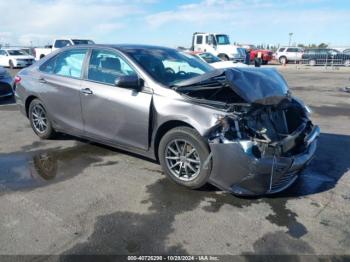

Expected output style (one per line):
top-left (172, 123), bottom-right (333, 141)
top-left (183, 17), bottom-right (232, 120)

top-left (0, 0), bottom-right (350, 47)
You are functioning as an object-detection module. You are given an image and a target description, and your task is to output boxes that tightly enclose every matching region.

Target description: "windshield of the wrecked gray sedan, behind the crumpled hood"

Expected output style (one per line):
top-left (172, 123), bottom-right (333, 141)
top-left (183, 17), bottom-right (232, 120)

top-left (123, 47), bottom-right (214, 87)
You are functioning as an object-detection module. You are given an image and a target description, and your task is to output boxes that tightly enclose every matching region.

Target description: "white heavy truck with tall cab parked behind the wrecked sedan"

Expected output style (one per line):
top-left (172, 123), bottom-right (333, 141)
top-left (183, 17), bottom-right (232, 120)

top-left (191, 32), bottom-right (245, 62)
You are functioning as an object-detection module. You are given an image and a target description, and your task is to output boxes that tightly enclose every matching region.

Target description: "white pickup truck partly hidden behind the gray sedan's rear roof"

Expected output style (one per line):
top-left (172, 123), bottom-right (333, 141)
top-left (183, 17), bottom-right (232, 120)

top-left (34, 38), bottom-right (94, 60)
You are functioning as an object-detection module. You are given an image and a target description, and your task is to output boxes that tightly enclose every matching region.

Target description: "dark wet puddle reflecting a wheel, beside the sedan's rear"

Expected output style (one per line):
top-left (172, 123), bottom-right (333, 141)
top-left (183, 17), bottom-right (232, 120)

top-left (0, 142), bottom-right (117, 194)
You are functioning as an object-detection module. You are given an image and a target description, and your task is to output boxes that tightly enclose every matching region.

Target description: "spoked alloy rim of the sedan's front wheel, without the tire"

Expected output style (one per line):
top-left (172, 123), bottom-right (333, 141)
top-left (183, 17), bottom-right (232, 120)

top-left (165, 139), bottom-right (201, 181)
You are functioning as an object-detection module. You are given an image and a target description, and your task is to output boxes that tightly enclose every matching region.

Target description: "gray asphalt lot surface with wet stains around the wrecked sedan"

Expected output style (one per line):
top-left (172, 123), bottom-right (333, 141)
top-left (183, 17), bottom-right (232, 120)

top-left (0, 66), bottom-right (350, 255)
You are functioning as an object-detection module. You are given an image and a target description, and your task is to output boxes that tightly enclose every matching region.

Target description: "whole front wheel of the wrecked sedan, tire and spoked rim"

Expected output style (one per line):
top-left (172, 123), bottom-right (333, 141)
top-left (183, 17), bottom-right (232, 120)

top-left (158, 127), bottom-right (212, 189)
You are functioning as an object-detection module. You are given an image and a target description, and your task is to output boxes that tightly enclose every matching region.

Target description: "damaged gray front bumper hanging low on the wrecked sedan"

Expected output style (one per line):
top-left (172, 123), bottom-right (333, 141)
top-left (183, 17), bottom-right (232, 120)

top-left (209, 126), bottom-right (320, 196)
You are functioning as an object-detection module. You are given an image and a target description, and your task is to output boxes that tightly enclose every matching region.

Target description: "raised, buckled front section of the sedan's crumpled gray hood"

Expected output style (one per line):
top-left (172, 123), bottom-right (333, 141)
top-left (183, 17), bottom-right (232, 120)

top-left (225, 67), bottom-right (288, 105)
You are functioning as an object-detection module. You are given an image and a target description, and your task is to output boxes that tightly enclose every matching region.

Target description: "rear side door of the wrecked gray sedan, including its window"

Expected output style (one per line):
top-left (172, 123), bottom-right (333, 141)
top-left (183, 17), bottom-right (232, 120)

top-left (37, 49), bottom-right (87, 133)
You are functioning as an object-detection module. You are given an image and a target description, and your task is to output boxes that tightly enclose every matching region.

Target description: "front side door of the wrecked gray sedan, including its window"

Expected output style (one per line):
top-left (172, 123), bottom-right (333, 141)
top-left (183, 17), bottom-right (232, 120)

top-left (81, 49), bottom-right (152, 149)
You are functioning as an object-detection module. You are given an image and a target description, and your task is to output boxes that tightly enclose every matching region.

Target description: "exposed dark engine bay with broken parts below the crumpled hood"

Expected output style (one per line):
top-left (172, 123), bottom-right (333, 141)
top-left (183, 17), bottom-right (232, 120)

top-left (208, 99), bottom-right (313, 158)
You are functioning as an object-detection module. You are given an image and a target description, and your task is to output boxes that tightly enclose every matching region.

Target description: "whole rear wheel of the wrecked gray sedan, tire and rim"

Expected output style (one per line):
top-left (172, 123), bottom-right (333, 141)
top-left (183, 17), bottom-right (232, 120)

top-left (28, 99), bottom-right (56, 139)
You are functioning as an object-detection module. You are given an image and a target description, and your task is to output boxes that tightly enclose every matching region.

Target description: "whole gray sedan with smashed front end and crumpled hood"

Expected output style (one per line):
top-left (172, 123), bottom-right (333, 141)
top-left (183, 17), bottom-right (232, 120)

top-left (14, 45), bottom-right (320, 195)
